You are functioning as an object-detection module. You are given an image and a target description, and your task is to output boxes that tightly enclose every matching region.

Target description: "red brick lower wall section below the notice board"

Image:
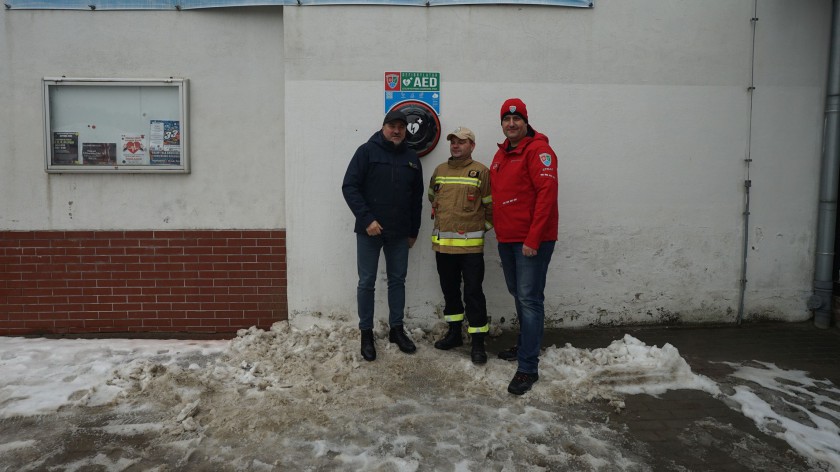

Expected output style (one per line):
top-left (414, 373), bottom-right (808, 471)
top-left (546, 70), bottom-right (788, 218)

top-left (0, 230), bottom-right (288, 336)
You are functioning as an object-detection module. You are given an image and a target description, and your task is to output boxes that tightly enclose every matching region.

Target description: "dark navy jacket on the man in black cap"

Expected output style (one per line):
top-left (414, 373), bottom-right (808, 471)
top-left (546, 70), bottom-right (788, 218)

top-left (341, 131), bottom-right (423, 238)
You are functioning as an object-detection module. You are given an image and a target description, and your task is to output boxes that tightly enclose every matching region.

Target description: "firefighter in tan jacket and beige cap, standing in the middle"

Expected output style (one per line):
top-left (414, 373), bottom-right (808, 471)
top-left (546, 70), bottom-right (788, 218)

top-left (428, 126), bottom-right (493, 364)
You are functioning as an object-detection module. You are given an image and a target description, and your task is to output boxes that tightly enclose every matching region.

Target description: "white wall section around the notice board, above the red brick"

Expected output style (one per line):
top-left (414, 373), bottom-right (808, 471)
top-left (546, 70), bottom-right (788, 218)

top-left (0, 8), bottom-right (285, 230)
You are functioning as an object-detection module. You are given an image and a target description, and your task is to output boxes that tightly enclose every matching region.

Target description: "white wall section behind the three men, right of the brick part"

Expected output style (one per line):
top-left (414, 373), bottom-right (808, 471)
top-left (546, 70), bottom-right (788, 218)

top-left (284, 0), bottom-right (831, 326)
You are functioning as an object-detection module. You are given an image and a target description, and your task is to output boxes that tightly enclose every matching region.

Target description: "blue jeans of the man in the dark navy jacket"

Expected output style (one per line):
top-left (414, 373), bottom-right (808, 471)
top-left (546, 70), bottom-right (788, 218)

top-left (356, 233), bottom-right (408, 329)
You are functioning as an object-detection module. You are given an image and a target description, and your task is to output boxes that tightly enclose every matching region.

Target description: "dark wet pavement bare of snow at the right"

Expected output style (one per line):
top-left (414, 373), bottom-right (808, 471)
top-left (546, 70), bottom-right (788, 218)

top-left (488, 322), bottom-right (840, 472)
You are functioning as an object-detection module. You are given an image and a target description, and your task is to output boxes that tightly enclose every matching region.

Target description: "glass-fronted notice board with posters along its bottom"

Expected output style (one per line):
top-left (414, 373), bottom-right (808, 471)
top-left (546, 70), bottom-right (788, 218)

top-left (43, 77), bottom-right (190, 173)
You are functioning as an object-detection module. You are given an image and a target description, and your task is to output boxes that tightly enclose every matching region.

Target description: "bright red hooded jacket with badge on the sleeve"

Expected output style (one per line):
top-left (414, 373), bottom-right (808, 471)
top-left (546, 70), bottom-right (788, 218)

top-left (490, 125), bottom-right (558, 249)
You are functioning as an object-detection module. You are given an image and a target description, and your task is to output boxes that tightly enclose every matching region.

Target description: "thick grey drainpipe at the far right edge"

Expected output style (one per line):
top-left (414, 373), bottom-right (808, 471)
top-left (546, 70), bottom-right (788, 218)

top-left (808, 0), bottom-right (840, 328)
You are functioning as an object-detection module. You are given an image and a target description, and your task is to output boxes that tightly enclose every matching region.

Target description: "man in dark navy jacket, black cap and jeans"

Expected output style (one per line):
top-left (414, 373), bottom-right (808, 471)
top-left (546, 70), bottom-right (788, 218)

top-left (341, 110), bottom-right (424, 361)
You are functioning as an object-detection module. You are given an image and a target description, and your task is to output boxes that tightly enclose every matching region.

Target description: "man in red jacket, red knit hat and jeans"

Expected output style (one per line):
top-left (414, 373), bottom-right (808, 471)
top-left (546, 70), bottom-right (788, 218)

top-left (490, 98), bottom-right (558, 395)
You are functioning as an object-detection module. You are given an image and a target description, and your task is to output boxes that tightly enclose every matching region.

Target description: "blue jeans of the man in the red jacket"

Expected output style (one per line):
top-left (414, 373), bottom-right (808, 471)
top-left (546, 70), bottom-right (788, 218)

top-left (499, 241), bottom-right (554, 374)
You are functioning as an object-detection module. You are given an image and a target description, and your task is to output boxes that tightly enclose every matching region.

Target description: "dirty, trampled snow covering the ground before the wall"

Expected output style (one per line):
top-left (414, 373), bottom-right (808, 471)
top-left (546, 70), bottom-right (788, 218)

top-left (0, 322), bottom-right (840, 471)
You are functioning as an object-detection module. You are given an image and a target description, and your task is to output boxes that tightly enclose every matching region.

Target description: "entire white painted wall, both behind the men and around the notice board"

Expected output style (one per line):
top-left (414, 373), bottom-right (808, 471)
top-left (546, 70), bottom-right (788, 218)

top-left (0, 0), bottom-right (831, 326)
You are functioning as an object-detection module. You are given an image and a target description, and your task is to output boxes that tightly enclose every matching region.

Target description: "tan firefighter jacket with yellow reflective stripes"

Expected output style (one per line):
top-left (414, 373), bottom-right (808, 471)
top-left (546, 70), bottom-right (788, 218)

top-left (428, 158), bottom-right (493, 254)
